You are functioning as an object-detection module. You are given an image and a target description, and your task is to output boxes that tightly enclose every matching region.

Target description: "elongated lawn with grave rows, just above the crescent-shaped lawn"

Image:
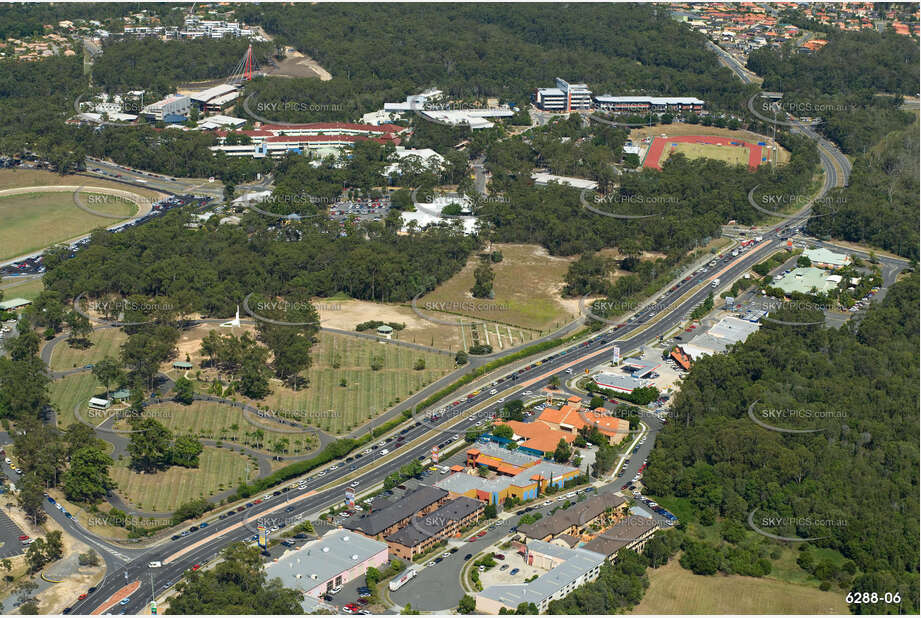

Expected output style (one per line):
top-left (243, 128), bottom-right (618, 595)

top-left (116, 401), bottom-right (316, 455)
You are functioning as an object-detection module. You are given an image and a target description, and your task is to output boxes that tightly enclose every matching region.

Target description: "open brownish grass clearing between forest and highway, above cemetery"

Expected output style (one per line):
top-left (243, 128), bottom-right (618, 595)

top-left (417, 244), bottom-right (578, 334)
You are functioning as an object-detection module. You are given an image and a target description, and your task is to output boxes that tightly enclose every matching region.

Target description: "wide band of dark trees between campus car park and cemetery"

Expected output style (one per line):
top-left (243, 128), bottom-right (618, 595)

top-left (39, 200), bottom-right (478, 315)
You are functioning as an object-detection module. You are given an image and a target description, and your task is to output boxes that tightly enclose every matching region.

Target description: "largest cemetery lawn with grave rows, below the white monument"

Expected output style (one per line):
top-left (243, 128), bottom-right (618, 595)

top-left (167, 327), bottom-right (454, 434)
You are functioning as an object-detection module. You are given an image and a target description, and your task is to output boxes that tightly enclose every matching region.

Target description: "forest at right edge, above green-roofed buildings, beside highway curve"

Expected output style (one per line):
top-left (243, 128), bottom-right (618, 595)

top-left (807, 123), bottom-right (919, 261)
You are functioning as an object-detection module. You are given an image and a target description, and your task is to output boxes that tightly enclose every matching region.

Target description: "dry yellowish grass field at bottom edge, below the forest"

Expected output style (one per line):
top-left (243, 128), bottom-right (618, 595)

top-left (632, 557), bottom-right (848, 614)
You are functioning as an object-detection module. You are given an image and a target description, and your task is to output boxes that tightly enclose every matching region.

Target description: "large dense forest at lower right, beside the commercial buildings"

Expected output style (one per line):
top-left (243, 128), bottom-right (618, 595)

top-left (643, 274), bottom-right (919, 613)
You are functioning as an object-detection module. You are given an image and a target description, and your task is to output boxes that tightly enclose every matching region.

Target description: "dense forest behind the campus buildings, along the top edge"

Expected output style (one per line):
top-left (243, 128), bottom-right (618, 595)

top-left (238, 3), bottom-right (756, 116)
